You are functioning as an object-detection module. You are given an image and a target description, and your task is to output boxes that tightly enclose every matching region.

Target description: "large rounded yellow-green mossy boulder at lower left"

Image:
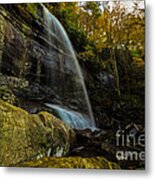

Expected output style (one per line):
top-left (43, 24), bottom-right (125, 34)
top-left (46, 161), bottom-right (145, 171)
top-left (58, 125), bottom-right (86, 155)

top-left (0, 100), bottom-right (75, 166)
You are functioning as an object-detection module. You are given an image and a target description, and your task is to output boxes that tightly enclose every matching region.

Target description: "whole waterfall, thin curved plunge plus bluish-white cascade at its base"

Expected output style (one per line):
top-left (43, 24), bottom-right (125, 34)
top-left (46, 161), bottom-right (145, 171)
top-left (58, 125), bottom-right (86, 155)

top-left (42, 5), bottom-right (95, 129)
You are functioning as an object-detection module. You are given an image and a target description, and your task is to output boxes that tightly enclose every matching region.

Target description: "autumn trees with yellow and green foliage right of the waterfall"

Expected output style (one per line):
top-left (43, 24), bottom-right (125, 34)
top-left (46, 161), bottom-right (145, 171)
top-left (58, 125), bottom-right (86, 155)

top-left (45, 1), bottom-right (145, 96)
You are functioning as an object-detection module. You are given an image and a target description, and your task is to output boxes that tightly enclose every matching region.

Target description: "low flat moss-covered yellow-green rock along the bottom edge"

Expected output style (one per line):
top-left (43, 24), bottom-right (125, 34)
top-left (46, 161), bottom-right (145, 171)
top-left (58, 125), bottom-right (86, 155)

top-left (18, 157), bottom-right (120, 169)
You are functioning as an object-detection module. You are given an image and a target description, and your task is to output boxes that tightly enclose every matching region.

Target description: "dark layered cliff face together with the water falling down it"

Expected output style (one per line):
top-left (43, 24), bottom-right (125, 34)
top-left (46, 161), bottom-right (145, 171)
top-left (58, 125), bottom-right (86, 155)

top-left (0, 3), bottom-right (93, 119)
